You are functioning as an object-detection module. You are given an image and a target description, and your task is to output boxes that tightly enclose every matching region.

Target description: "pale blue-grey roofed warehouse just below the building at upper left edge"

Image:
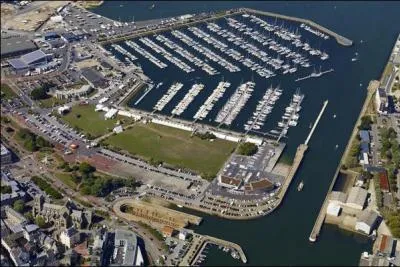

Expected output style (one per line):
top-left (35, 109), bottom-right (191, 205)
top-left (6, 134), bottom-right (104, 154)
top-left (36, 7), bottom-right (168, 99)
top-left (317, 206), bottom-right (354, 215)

top-left (8, 49), bottom-right (52, 72)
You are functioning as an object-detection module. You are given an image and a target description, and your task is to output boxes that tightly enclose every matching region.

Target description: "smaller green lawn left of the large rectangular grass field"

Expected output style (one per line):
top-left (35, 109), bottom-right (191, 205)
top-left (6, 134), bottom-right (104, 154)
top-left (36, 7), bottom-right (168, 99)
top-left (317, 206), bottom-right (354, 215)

top-left (61, 105), bottom-right (128, 138)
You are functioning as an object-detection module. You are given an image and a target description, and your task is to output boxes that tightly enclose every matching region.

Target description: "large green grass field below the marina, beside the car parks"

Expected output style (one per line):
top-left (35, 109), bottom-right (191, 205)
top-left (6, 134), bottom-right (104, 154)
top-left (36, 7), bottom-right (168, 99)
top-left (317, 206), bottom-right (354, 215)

top-left (105, 124), bottom-right (237, 178)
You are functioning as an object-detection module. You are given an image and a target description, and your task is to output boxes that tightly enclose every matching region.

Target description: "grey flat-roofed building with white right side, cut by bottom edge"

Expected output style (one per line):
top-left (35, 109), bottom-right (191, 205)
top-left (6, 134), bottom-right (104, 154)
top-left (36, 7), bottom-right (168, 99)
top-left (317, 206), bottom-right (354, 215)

top-left (110, 229), bottom-right (144, 266)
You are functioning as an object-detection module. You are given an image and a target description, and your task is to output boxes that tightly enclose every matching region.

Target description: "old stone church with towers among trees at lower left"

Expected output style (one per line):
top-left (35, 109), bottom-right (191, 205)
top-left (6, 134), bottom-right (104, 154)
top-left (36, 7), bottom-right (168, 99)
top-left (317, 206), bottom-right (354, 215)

top-left (32, 194), bottom-right (93, 229)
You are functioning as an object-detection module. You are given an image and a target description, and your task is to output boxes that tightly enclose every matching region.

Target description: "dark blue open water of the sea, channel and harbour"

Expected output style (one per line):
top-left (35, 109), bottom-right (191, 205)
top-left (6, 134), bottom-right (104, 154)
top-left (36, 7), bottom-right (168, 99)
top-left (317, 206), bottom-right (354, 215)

top-left (93, 1), bottom-right (400, 266)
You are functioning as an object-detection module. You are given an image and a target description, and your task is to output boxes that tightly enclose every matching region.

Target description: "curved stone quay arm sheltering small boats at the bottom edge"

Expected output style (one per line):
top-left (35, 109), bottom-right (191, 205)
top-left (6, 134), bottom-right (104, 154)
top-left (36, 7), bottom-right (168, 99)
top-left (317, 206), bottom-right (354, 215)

top-left (179, 234), bottom-right (247, 266)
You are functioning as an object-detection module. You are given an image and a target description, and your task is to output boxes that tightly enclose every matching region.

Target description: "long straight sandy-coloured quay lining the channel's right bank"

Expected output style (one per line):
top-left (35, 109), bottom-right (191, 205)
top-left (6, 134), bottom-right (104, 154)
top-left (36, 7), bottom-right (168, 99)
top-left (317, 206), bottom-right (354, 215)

top-left (309, 81), bottom-right (379, 242)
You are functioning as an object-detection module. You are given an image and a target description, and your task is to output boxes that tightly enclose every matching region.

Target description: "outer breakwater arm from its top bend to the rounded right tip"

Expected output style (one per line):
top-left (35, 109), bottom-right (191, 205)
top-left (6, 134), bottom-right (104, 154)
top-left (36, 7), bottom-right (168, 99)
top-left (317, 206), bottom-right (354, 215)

top-left (241, 8), bottom-right (353, 46)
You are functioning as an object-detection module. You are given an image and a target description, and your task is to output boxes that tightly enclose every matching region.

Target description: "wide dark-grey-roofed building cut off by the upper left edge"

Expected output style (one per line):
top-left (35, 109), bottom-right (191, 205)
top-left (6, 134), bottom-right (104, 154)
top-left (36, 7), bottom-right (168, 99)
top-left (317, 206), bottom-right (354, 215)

top-left (1, 34), bottom-right (37, 59)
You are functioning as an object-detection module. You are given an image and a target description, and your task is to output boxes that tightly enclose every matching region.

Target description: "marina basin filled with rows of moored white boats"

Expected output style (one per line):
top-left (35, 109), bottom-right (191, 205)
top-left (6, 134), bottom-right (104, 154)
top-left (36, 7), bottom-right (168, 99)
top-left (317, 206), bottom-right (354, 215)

top-left (104, 7), bottom-right (344, 140)
